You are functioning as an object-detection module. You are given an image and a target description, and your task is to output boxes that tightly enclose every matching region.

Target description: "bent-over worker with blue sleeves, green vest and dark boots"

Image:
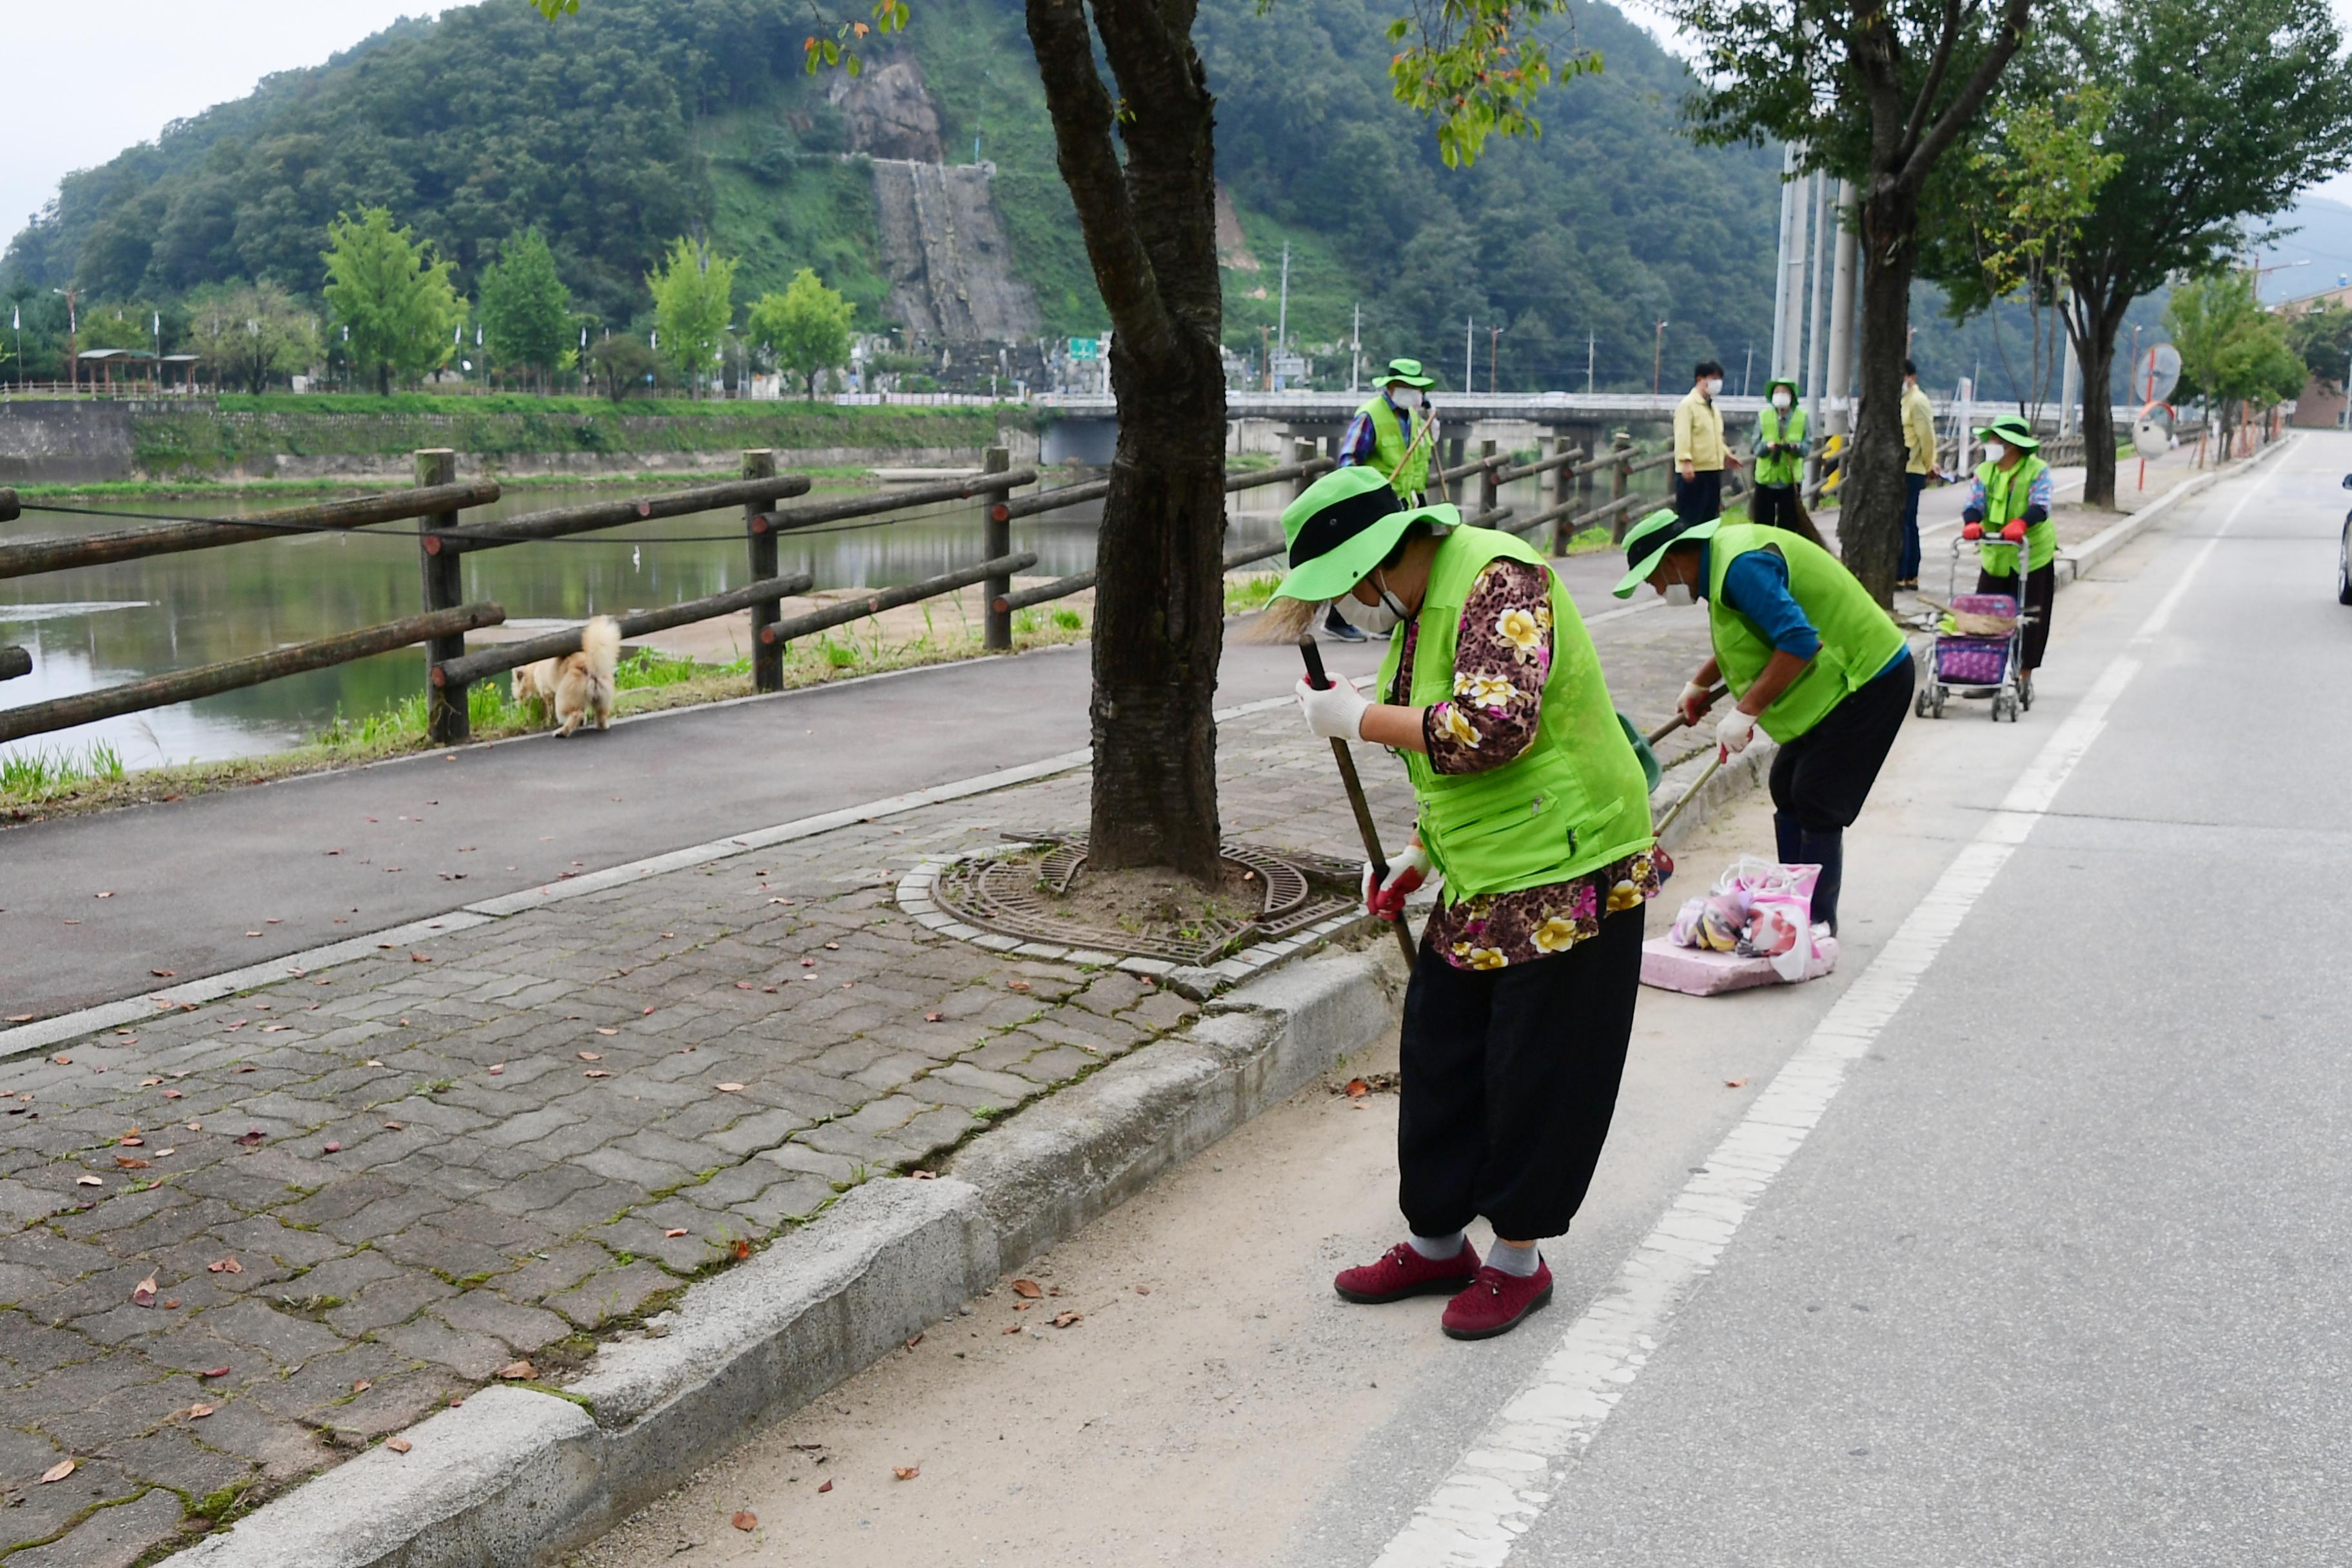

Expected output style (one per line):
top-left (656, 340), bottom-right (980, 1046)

top-left (1616, 510), bottom-right (1919, 936)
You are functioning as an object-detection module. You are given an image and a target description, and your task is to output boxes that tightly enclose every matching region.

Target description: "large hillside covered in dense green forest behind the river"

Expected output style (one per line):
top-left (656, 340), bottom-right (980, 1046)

top-left (0, 0), bottom-right (1778, 388)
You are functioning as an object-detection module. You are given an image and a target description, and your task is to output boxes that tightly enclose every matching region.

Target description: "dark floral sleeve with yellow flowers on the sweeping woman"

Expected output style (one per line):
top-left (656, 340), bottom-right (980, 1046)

top-left (1420, 560), bottom-right (1553, 774)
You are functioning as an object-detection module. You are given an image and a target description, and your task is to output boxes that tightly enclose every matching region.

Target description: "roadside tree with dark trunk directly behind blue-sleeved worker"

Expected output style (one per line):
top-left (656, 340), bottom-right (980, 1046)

top-left (1665, 0), bottom-right (2032, 604)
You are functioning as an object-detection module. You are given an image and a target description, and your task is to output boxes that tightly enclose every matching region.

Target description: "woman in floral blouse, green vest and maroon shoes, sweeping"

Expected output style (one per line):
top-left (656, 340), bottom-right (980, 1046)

top-left (1268, 468), bottom-right (1672, 1340)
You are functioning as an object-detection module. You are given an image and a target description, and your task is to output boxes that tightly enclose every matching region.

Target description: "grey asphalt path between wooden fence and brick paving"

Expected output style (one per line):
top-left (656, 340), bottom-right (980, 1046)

top-left (0, 644), bottom-right (1380, 1015)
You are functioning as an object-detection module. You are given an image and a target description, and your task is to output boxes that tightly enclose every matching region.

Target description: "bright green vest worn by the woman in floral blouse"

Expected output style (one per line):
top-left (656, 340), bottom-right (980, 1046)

top-left (1380, 527), bottom-right (1656, 903)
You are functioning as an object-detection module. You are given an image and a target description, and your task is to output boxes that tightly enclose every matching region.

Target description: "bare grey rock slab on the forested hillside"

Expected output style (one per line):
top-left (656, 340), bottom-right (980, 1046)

top-left (872, 157), bottom-right (1044, 343)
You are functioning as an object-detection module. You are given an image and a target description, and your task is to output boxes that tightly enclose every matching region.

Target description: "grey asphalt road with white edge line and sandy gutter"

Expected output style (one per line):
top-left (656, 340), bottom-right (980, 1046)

top-left (574, 435), bottom-right (2352, 1568)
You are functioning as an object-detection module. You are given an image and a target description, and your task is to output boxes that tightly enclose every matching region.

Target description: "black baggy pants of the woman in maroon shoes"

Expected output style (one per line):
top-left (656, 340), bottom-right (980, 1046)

top-left (1397, 907), bottom-right (1642, 1241)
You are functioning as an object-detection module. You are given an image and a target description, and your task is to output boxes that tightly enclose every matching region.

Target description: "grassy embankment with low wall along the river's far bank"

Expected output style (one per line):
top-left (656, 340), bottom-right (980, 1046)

top-left (0, 397), bottom-right (1037, 484)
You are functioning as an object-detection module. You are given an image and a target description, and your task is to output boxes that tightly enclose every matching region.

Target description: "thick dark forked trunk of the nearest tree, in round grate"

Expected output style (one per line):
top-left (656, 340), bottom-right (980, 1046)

top-left (1028, 0), bottom-right (1226, 879)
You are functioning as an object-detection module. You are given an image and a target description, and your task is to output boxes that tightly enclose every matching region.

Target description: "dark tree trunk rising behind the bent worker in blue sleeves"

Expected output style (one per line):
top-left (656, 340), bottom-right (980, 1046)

top-left (1837, 181), bottom-right (1919, 604)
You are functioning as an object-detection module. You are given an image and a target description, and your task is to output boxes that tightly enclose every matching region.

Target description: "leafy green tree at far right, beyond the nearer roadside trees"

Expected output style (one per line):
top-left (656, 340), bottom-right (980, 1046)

top-left (2032, 0), bottom-right (2352, 505)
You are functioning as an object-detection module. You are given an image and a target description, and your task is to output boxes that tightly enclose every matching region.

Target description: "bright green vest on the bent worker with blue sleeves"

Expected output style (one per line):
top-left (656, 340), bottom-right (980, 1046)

top-left (1707, 522), bottom-right (1908, 745)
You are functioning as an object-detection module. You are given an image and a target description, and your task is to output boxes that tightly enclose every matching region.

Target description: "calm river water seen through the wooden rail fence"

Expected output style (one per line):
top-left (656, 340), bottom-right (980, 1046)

top-left (0, 475), bottom-right (1656, 769)
